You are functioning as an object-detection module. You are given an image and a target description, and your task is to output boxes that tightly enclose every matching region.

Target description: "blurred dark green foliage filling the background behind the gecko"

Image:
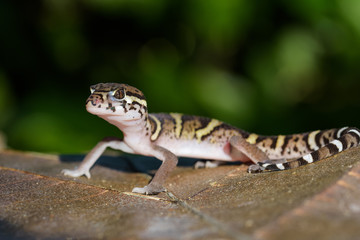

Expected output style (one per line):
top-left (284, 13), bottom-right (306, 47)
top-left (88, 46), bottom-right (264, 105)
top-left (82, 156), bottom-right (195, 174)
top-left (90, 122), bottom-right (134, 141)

top-left (0, 0), bottom-right (360, 153)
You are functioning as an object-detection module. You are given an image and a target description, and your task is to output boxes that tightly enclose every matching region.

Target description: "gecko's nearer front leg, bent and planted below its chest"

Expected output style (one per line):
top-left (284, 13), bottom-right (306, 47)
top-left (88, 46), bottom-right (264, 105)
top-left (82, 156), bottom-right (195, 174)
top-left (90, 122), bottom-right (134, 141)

top-left (132, 145), bottom-right (178, 195)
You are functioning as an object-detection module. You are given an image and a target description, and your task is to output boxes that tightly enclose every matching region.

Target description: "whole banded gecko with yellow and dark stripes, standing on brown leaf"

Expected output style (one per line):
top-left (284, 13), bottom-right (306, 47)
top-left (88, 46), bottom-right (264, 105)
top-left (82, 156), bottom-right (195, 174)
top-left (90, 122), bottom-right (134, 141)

top-left (63, 83), bottom-right (360, 194)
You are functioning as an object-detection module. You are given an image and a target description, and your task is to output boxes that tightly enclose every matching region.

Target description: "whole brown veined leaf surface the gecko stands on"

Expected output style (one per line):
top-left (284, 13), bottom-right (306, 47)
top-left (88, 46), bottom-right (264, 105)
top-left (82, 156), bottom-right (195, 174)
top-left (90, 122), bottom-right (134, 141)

top-left (0, 148), bottom-right (360, 239)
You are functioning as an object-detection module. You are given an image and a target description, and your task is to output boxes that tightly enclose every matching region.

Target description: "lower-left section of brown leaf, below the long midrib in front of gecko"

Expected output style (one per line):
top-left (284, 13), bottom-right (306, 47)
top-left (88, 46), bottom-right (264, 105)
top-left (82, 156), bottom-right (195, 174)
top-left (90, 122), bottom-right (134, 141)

top-left (0, 167), bottom-right (227, 239)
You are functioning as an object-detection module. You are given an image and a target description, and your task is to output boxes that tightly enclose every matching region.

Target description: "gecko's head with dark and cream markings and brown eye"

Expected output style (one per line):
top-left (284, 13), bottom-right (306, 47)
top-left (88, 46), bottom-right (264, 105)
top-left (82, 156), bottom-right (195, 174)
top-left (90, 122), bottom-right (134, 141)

top-left (86, 83), bottom-right (147, 120)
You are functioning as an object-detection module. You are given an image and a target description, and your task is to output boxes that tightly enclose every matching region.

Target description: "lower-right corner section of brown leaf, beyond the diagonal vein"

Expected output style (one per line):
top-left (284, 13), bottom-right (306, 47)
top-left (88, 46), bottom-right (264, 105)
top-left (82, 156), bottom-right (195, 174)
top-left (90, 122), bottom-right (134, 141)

top-left (256, 159), bottom-right (360, 240)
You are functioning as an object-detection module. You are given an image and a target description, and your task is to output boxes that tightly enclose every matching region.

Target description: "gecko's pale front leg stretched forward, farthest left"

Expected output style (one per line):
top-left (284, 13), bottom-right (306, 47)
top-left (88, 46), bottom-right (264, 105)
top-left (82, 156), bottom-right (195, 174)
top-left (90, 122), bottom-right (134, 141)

top-left (61, 137), bottom-right (133, 178)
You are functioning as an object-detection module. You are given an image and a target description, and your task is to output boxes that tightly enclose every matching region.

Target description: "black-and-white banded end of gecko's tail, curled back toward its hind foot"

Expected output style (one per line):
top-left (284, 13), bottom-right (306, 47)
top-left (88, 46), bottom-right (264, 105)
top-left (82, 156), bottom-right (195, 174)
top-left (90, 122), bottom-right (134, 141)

top-left (258, 127), bottom-right (360, 172)
